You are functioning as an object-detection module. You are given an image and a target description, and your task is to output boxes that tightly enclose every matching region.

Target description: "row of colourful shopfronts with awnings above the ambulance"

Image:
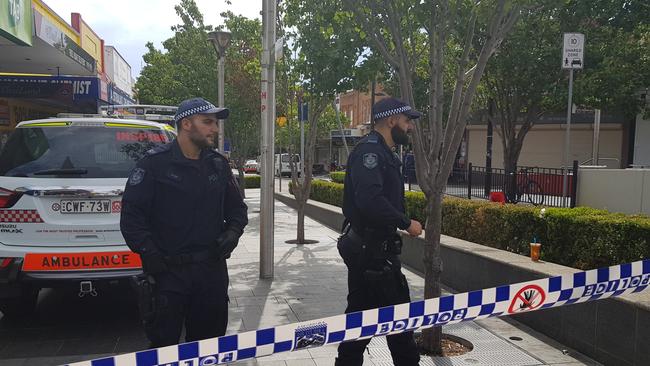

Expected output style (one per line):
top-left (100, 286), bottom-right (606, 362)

top-left (0, 0), bottom-right (133, 147)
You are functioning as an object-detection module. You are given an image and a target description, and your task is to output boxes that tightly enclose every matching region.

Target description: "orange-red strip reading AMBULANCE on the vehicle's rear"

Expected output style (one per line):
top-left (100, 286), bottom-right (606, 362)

top-left (23, 252), bottom-right (142, 272)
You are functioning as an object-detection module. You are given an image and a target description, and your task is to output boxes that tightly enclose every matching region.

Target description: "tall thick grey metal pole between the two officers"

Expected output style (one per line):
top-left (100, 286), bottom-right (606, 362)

top-left (260, 0), bottom-right (276, 278)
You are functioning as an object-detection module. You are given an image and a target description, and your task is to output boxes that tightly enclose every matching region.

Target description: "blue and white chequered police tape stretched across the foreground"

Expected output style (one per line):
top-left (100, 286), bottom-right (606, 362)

top-left (70, 260), bottom-right (650, 366)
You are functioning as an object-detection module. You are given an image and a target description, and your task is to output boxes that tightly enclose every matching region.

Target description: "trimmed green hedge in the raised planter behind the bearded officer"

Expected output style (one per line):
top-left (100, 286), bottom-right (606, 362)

top-left (310, 180), bottom-right (650, 269)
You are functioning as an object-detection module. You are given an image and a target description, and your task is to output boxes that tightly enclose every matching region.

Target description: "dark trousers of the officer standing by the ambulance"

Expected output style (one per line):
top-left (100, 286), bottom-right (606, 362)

top-left (145, 259), bottom-right (228, 348)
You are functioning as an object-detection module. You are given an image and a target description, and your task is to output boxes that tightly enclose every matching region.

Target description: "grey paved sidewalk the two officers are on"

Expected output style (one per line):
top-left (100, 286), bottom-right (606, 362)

top-left (228, 189), bottom-right (598, 366)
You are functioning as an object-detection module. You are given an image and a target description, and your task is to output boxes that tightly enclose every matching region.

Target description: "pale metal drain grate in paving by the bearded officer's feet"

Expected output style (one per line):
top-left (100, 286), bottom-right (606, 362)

top-left (365, 322), bottom-right (543, 366)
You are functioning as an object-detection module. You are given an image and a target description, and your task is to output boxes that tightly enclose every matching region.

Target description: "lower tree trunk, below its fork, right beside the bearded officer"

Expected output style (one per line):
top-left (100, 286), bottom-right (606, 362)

top-left (422, 192), bottom-right (443, 355)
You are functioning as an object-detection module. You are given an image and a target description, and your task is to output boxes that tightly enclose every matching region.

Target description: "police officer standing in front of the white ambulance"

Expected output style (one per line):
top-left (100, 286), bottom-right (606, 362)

top-left (120, 98), bottom-right (248, 347)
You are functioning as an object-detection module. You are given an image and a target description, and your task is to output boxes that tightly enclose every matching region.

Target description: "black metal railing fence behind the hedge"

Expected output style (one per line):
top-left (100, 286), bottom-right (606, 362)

top-left (447, 161), bottom-right (578, 207)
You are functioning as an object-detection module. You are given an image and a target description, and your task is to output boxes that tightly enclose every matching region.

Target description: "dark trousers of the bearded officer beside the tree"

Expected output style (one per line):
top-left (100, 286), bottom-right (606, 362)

top-left (335, 235), bottom-right (420, 366)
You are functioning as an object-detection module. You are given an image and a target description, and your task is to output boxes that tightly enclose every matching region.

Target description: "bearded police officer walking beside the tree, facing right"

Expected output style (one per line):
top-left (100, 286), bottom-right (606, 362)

top-left (336, 98), bottom-right (422, 366)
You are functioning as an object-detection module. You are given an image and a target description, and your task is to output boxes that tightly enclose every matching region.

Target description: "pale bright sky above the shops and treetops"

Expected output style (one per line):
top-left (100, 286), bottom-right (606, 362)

top-left (45, 0), bottom-right (262, 78)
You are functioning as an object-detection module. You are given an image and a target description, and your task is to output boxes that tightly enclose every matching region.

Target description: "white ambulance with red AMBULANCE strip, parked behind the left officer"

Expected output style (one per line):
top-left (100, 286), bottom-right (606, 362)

top-left (0, 118), bottom-right (175, 317)
